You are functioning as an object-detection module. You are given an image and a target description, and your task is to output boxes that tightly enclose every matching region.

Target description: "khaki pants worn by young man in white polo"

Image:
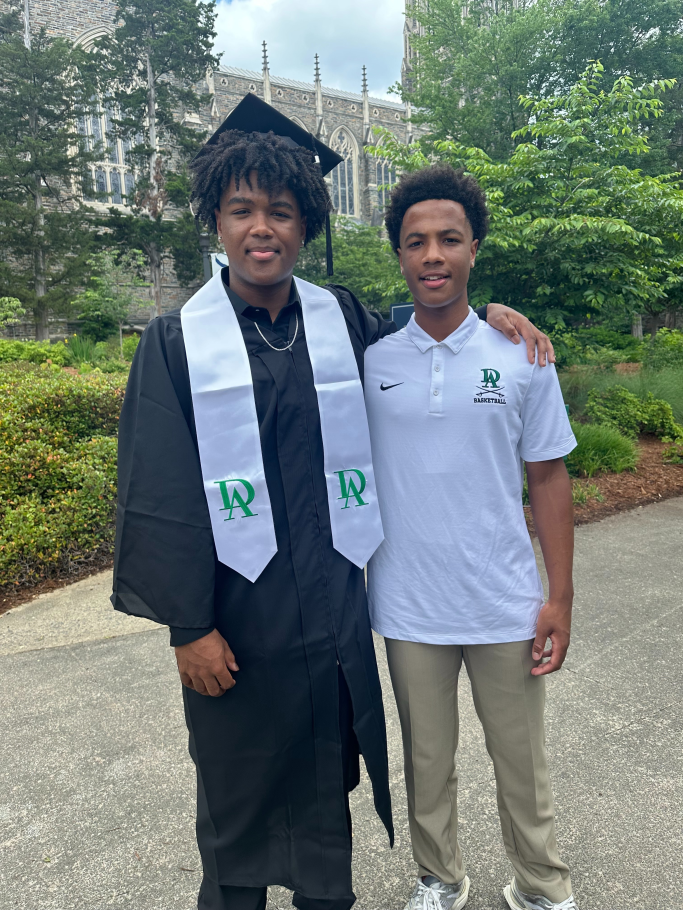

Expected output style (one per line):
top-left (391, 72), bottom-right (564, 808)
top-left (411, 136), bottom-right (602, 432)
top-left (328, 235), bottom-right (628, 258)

top-left (386, 639), bottom-right (572, 903)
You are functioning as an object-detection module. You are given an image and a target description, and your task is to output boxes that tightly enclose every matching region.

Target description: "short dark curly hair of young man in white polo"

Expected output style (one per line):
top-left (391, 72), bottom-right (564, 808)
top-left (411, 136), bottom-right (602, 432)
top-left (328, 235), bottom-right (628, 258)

top-left (384, 164), bottom-right (489, 252)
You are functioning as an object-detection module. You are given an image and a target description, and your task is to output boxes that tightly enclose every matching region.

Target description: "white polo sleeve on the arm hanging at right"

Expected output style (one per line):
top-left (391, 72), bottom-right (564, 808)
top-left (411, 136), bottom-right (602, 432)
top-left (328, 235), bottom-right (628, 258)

top-left (519, 363), bottom-right (576, 461)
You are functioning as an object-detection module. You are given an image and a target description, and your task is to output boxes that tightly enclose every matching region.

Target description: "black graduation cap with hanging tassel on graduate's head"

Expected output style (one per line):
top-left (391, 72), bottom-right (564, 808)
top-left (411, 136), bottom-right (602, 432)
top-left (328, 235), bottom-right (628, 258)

top-left (199, 92), bottom-right (344, 276)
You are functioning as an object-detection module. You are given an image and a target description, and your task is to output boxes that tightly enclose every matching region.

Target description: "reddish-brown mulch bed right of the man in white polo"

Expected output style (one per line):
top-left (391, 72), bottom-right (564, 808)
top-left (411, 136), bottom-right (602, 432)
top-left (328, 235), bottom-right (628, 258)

top-left (524, 437), bottom-right (683, 537)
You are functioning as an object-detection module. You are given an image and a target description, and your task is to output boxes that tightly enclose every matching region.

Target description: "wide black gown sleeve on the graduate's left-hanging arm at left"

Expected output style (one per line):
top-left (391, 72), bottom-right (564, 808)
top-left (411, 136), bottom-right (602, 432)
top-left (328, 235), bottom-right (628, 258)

top-left (111, 314), bottom-right (215, 640)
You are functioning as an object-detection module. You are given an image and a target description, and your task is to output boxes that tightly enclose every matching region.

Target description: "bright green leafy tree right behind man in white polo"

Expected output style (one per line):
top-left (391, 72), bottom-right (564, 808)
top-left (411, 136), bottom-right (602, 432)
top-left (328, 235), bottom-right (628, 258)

top-left (374, 63), bottom-right (683, 328)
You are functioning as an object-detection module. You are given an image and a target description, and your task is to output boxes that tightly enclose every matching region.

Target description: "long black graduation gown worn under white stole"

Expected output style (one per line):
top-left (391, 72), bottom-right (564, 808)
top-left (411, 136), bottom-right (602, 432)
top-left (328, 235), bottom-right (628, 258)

top-left (112, 286), bottom-right (395, 899)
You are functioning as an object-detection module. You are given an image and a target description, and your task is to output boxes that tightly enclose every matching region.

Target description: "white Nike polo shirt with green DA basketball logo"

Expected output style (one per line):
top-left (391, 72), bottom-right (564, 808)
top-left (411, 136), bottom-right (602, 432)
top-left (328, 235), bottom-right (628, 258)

top-left (365, 309), bottom-right (576, 645)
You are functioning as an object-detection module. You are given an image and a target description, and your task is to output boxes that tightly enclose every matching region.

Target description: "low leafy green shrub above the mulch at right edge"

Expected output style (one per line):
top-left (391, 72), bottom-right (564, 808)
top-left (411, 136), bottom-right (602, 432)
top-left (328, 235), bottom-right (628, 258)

top-left (586, 385), bottom-right (683, 438)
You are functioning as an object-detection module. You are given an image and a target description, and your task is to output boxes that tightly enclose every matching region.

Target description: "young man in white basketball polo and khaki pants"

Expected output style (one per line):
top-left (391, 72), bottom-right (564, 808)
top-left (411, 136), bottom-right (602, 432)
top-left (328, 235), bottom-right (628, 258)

top-left (365, 165), bottom-right (576, 910)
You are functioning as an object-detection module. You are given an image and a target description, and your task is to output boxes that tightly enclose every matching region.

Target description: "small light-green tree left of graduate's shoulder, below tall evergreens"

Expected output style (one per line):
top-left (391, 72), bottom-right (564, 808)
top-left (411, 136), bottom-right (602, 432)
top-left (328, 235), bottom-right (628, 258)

top-left (74, 250), bottom-right (148, 350)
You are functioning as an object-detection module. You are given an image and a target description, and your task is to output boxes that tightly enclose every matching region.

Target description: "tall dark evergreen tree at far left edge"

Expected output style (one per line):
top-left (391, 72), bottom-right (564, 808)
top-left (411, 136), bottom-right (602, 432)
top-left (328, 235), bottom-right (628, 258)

top-left (0, 12), bottom-right (100, 340)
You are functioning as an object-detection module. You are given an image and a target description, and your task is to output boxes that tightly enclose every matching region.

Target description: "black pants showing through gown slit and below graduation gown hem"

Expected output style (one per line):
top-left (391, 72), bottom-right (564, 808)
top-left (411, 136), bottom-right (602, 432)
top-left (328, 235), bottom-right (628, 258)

top-left (197, 668), bottom-right (360, 910)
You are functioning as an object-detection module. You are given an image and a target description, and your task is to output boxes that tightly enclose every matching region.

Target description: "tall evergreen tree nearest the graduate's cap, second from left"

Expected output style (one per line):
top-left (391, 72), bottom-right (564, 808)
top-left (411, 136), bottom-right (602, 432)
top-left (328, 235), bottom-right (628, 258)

top-left (97, 0), bottom-right (218, 314)
